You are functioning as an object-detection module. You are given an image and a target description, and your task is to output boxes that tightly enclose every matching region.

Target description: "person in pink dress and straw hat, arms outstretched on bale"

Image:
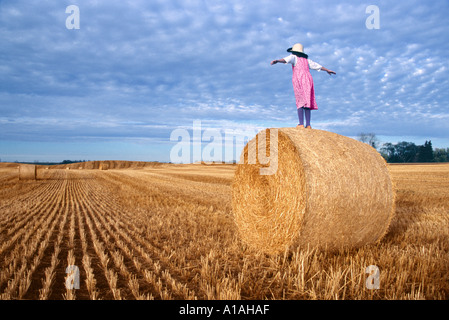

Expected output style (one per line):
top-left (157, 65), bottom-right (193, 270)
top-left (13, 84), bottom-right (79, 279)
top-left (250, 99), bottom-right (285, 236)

top-left (271, 43), bottom-right (336, 129)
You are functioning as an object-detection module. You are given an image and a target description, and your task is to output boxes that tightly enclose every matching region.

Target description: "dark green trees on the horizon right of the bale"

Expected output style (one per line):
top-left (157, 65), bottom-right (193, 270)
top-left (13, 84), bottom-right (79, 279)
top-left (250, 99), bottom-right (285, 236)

top-left (359, 133), bottom-right (449, 163)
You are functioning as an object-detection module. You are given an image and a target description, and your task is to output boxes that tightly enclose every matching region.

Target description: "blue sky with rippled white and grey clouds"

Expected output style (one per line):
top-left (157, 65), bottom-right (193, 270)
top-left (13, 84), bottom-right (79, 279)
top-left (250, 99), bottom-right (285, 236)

top-left (0, 0), bottom-right (449, 162)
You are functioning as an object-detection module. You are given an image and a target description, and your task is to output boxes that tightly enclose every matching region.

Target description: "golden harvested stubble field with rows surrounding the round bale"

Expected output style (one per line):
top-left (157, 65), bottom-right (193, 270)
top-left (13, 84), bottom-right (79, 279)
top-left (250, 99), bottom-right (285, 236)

top-left (0, 164), bottom-right (449, 300)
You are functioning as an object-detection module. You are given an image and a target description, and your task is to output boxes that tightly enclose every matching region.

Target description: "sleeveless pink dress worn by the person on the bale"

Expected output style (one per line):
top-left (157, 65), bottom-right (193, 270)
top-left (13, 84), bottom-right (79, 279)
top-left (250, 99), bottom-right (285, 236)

top-left (292, 57), bottom-right (318, 110)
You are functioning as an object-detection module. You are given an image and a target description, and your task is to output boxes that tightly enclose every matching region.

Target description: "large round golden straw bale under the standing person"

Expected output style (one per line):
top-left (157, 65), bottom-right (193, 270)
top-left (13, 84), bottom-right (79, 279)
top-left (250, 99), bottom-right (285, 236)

top-left (232, 128), bottom-right (395, 253)
